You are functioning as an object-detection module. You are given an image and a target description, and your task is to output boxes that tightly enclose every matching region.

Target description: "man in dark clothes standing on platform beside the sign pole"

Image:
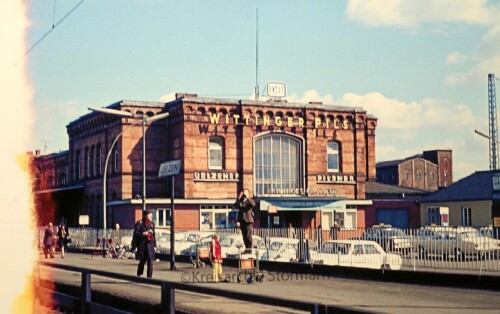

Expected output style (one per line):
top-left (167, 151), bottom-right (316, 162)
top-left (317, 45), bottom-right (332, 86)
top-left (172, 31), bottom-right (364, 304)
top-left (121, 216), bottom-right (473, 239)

top-left (134, 210), bottom-right (156, 278)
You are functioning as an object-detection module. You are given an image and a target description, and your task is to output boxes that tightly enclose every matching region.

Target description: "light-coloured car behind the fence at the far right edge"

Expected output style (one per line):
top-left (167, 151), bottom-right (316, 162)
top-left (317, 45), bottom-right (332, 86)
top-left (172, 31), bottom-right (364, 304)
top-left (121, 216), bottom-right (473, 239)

top-left (413, 227), bottom-right (500, 261)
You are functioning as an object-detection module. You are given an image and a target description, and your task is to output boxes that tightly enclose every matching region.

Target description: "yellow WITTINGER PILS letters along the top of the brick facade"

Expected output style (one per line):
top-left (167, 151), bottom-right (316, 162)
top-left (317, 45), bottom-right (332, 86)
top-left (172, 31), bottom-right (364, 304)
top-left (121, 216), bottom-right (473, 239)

top-left (209, 113), bottom-right (349, 130)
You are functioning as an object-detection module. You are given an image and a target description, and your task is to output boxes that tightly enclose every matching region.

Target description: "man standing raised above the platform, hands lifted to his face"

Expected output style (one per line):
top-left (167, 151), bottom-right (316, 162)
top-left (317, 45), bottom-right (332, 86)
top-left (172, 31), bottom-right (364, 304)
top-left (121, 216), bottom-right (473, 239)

top-left (234, 189), bottom-right (255, 253)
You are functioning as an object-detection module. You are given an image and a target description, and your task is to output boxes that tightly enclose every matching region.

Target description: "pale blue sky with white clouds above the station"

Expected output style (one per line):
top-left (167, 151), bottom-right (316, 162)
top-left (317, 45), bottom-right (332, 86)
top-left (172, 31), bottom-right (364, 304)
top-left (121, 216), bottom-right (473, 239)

top-left (24, 0), bottom-right (500, 181)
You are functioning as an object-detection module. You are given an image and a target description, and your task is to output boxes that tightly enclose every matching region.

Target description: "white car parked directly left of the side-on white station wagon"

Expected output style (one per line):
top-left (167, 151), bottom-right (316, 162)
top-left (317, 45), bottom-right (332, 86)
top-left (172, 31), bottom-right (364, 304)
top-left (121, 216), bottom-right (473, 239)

top-left (261, 237), bottom-right (299, 262)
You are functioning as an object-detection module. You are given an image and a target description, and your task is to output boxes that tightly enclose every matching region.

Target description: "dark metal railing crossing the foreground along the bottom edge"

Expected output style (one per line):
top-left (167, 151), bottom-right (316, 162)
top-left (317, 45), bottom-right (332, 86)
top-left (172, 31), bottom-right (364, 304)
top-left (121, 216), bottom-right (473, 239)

top-left (38, 262), bottom-right (363, 313)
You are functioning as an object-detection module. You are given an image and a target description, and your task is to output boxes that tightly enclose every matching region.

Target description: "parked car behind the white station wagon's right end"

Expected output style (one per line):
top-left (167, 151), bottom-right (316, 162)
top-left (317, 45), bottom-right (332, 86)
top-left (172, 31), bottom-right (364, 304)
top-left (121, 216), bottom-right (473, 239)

top-left (363, 225), bottom-right (412, 253)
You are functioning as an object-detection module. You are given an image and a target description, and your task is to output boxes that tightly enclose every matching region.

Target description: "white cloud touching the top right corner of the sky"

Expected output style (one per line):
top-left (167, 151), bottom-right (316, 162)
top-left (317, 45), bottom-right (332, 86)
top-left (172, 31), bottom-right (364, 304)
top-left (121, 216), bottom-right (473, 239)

top-left (346, 0), bottom-right (500, 27)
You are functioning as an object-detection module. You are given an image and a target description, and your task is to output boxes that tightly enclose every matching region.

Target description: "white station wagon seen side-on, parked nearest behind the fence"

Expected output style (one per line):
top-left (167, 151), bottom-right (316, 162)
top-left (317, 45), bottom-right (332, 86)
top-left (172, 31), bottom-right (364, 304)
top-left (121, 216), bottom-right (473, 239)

top-left (309, 240), bottom-right (402, 270)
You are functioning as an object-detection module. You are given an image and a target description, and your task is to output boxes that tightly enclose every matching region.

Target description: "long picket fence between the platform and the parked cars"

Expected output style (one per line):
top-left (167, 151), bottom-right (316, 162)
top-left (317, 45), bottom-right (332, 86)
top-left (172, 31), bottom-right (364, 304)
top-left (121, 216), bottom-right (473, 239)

top-left (39, 226), bottom-right (500, 272)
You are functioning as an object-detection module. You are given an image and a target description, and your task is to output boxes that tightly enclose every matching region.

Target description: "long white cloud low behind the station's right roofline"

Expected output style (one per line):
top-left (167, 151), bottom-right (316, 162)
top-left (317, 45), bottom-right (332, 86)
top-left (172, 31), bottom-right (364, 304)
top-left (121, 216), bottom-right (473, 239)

top-left (287, 90), bottom-right (488, 180)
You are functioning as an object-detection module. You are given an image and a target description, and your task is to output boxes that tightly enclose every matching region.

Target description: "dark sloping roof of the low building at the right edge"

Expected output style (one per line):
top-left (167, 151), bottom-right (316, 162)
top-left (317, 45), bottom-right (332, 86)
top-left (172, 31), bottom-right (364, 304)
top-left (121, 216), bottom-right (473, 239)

top-left (421, 170), bottom-right (500, 203)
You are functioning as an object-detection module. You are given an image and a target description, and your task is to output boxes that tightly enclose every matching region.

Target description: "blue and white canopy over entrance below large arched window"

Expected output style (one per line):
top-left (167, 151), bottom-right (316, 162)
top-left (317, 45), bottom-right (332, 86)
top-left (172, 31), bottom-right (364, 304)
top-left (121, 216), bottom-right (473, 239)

top-left (260, 197), bottom-right (346, 212)
